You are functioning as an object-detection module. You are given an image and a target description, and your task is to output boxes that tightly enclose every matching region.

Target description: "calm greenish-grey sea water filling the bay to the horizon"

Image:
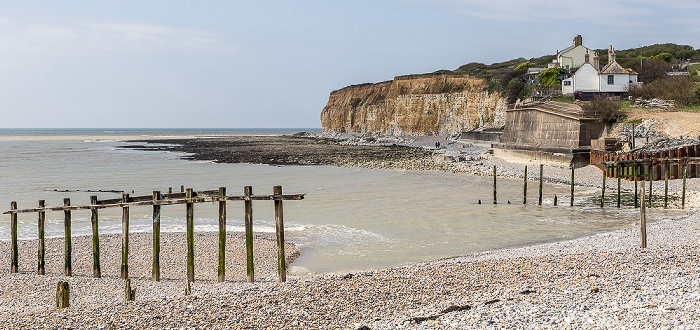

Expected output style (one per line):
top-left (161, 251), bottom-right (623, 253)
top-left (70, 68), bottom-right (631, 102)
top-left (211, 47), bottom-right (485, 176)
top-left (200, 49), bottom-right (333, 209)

top-left (0, 129), bottom-right (681, 273)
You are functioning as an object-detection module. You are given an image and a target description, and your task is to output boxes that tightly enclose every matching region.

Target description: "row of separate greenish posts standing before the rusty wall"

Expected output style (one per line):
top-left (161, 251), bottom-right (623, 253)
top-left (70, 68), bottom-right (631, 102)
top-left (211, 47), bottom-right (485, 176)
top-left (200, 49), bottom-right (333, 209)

top-left (490, 159), bottom-right (700, 209)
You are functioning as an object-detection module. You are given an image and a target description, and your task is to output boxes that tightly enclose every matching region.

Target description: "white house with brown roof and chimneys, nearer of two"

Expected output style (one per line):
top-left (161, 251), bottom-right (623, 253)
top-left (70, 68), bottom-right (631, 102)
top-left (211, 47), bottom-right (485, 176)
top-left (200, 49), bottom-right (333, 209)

top-left (561, 46), bottom-right (639, 100)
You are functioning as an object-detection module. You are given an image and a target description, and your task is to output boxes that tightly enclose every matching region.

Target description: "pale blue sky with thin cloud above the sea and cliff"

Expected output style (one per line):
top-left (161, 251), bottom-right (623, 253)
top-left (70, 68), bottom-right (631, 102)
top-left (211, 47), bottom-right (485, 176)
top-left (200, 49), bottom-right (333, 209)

top-left (0, 0), bottom-right (700, 128)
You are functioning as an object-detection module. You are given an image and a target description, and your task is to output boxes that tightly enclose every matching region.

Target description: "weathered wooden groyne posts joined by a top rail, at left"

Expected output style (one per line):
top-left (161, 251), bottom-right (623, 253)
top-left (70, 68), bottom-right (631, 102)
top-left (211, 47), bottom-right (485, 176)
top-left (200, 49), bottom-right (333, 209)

top-left (4, 186), bottom-right (304, 282)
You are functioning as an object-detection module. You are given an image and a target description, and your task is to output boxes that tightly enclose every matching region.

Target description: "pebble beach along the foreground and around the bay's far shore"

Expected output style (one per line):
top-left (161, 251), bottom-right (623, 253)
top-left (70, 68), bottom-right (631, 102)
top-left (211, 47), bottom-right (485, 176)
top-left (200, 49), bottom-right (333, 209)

top-left (0, 138), bottom-right (700, 329)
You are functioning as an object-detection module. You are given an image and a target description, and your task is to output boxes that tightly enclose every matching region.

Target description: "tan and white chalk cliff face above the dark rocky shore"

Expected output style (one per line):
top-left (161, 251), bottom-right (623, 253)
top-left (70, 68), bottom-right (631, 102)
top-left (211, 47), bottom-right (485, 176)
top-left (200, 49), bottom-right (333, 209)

top-left (321, 75), bottom-right (507, 135)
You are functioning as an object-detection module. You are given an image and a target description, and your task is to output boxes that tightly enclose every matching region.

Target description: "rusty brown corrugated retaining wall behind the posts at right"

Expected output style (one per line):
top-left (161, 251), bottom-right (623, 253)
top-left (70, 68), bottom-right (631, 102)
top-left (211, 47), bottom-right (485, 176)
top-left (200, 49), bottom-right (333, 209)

top-left (591, 139), bottom-right (700, 181)
